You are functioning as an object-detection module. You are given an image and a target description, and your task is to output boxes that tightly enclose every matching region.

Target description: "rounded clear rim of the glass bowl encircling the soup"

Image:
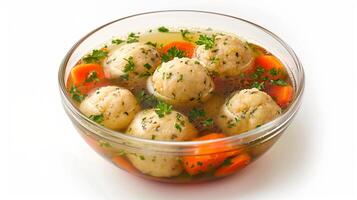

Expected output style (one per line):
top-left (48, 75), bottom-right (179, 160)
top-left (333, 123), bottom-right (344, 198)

top-left (58, 10), bottom-right (305, 148)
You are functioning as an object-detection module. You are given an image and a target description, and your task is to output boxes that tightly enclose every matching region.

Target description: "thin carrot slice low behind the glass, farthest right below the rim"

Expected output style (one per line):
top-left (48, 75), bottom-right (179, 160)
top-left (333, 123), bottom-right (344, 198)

top-left (214, 153), bottom-right (251, 177)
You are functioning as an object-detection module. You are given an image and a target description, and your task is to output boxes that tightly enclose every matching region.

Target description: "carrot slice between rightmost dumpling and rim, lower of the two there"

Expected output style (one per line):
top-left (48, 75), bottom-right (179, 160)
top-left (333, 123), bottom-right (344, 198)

top-left (267, 85), bottom-right (294, 108)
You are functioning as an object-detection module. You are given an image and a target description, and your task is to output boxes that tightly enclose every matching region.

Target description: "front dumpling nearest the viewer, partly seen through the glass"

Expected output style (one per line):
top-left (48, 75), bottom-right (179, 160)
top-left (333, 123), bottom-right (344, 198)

top-left (126, 109), bottom-right (197, 177)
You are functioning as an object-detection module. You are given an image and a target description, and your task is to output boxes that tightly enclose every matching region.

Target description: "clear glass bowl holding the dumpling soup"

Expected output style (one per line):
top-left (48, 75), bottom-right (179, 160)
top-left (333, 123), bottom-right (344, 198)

top-left (58, 10), bottom-right (304, 183)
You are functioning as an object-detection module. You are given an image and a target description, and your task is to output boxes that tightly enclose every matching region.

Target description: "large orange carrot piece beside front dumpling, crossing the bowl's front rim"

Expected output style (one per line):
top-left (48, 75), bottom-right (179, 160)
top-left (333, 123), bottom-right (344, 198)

top-left (182, 133), bottom-right (239, 176)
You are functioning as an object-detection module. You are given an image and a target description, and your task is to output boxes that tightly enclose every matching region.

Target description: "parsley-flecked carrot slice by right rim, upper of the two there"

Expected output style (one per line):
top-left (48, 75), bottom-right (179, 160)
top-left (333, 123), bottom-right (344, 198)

top-left (255, 55), bottom-right (286, 80)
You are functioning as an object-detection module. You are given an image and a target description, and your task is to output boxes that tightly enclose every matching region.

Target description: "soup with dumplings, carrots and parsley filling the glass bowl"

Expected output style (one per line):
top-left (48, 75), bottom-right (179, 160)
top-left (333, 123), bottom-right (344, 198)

top-left (67, 27), bottom-right (294, 178)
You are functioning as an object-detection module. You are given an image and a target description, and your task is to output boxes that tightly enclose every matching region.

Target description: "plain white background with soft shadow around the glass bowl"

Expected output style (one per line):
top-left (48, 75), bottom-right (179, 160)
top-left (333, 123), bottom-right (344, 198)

top-left (0, 0), bottom-right (357, 200)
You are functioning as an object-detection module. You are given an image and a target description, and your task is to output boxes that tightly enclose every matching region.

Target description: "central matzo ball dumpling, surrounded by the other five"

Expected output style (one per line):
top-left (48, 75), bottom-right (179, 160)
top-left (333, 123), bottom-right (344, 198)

top-left (148, 58), bottom-right (214, 105)
